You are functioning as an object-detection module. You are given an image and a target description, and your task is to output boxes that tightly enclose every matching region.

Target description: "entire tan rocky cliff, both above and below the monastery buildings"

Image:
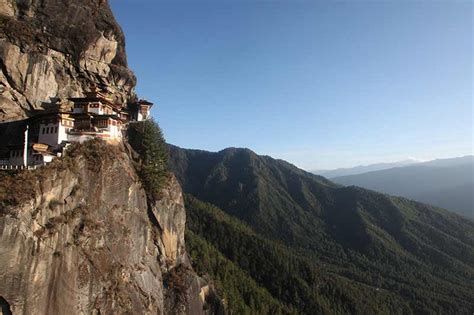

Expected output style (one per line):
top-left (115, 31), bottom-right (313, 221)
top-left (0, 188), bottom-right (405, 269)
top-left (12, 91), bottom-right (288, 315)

top-left (0, 0), bottom-right (214, 314)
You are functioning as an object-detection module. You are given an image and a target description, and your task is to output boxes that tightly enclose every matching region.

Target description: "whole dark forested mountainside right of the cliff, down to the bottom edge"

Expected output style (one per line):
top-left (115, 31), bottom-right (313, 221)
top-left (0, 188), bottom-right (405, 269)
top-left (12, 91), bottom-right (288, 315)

top-left (170, 146), bottom-right (474, 314)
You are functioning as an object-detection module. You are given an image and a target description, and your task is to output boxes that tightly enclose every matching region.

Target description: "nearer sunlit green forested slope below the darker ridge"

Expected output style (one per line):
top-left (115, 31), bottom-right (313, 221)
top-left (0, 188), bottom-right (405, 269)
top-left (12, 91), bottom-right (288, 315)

top-left (186, 197), bottom-right (409, 314)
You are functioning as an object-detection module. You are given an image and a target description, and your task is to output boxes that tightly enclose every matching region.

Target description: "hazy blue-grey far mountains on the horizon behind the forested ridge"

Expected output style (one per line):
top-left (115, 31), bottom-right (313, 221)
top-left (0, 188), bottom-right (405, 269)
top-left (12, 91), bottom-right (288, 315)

top-left (330, 156), bottom-right (474, 218)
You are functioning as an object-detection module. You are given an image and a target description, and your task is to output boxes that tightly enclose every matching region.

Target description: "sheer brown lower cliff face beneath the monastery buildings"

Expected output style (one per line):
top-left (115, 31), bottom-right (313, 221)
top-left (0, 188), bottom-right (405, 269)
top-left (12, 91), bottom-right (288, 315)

top-left (0, 141), bottom-right (204, 314)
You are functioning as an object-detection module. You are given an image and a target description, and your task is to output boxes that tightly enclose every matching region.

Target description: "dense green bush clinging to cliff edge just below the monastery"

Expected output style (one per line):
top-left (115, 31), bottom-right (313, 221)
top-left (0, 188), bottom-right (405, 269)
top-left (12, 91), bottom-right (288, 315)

top-left (127, 120), bottom-right (169, 199)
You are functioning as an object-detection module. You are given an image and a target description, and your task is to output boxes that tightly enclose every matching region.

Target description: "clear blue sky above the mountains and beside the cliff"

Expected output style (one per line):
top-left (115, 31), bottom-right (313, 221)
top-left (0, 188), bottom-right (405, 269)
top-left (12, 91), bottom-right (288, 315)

top-left (110, 0), bottom-right (474, 170)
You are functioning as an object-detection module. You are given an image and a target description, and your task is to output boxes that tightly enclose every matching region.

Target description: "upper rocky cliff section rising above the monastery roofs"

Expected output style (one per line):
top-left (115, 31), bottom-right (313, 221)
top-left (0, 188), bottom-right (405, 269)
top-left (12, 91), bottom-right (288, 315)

top-left (0, 0), bottom-right (136, 121)
